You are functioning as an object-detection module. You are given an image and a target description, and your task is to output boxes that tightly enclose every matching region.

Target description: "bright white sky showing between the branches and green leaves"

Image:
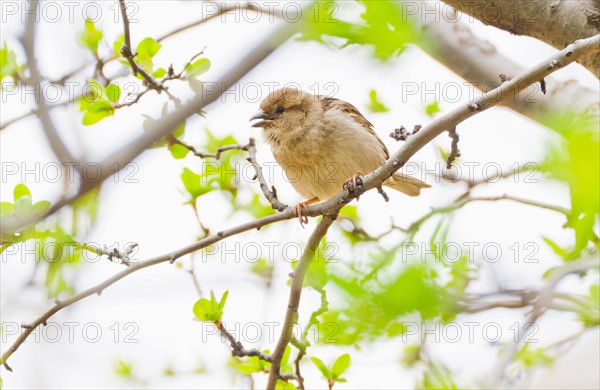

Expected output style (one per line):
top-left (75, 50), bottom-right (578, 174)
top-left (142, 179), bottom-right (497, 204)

top-left (0, 1), bottom-right (598, 389)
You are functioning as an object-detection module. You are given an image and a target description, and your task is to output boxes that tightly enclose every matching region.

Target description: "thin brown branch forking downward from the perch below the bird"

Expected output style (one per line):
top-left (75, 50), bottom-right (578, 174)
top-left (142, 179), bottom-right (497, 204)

top-left (267, 215), bottom-right (339, 390)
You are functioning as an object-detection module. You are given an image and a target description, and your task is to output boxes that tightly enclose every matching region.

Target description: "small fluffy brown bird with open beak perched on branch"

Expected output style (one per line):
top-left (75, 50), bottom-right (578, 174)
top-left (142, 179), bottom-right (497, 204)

top-left (250, 88), bottom-right (430, 223)
